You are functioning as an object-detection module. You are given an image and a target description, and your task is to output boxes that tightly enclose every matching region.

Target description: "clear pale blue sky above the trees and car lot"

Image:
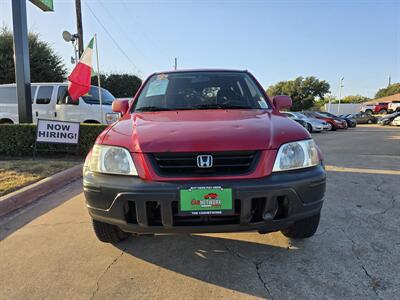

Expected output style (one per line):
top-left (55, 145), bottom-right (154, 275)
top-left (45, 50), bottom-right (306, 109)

top-left (0, 0), bottom-right (400, 97)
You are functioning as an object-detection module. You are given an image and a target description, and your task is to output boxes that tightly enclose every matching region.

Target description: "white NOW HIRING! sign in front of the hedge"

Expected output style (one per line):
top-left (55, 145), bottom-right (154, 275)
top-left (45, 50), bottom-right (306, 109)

top-left (36, 119), bottom-right (79, 144)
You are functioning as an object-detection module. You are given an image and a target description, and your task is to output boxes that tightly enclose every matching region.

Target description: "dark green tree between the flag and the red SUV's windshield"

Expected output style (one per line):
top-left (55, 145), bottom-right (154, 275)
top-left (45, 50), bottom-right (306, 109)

top-left (92, 74), bottom-right (142, 98)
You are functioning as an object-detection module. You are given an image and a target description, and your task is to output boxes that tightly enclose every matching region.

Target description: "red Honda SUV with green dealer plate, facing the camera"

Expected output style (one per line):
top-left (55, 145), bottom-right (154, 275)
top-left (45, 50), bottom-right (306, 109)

top-left (83, 70), bottom-right (326, 243)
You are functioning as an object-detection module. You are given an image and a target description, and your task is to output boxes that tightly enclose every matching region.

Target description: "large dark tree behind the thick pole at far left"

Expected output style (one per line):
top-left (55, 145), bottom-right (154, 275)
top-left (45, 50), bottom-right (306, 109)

top-left (0, 27), bottom-right (67, 84)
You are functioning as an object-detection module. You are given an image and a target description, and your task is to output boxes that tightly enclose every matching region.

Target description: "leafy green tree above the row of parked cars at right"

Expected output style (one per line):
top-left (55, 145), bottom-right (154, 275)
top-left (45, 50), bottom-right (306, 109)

top-left (267, 76), bottom-right (330, 111)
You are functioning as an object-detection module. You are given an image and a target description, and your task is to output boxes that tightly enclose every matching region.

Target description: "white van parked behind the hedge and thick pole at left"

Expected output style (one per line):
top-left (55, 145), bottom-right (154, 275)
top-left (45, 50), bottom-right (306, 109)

top-left (0, 83), bottom-right (119, 124)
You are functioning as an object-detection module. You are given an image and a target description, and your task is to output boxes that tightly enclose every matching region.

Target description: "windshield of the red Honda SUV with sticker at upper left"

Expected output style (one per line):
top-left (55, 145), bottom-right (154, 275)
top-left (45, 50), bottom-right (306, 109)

top-left (134, 72), bottom-right (269, 111)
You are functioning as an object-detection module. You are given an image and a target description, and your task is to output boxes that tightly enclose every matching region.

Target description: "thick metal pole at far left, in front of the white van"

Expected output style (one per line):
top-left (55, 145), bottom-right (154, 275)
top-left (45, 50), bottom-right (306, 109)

top-left (11, 0), bottom-right (32, 123)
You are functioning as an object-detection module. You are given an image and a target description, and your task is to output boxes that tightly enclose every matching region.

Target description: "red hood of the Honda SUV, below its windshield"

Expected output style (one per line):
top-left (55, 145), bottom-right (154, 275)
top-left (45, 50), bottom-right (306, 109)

top-left (101, 109), bottom-right (310, 153)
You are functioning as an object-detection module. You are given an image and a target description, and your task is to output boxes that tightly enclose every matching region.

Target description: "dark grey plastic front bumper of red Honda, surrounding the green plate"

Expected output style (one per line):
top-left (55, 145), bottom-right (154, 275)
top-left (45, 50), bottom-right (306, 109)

top-left (83, 165), bottom-right (326, 233)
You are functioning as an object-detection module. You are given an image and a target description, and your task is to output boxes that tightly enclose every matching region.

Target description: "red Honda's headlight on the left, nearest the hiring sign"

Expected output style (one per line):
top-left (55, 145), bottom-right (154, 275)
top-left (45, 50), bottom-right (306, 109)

top-left (85, 145), bottom-right (137, 176)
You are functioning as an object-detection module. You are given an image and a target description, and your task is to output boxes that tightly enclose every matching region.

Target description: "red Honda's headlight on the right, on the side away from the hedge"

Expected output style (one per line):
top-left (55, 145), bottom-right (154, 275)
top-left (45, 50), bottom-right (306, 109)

top-left (272, 140), bottom-right (320, 172)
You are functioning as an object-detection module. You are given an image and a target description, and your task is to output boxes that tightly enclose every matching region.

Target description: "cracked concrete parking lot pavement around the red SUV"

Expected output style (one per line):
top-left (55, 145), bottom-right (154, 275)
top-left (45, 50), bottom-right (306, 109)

top-left (0, 126), bottom-right (400, 299)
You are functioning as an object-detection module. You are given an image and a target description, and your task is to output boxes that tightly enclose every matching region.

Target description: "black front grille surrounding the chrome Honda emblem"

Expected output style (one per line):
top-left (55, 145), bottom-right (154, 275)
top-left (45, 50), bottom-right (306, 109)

top-left (149, 151), bottom-right (260, 177)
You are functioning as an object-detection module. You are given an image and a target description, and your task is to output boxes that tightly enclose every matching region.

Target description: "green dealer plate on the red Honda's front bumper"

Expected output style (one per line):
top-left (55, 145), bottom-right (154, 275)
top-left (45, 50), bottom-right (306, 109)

top-left (179, 187), bottom-right (234, 216)
